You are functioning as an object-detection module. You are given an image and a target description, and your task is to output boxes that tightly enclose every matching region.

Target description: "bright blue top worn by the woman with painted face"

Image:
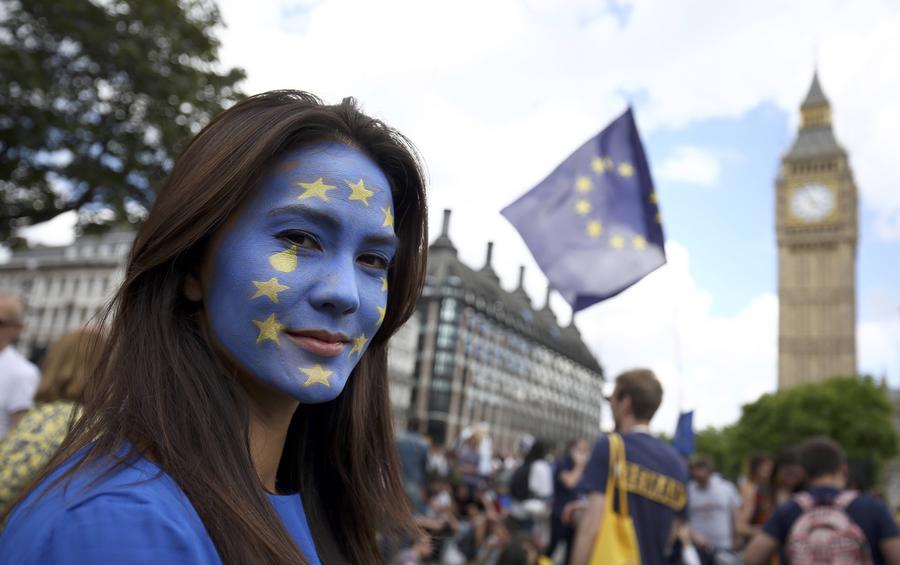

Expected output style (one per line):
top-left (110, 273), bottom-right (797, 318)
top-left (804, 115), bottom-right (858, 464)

top-left (0, 448), bottom-right (320, 565)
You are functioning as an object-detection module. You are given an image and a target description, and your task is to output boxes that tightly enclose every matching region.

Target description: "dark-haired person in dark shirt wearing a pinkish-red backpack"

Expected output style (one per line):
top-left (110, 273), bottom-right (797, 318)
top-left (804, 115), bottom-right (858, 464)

top-left (744, 438), bottom-right (900, 565)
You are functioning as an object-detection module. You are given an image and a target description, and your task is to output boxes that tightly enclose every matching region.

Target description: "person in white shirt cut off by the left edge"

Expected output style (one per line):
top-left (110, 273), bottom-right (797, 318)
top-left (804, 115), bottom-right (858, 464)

top-left (0, 293), bottom-right (41, 438)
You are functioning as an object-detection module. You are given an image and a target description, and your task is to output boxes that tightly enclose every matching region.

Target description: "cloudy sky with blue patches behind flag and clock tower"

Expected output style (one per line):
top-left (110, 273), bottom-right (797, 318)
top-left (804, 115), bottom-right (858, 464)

top-left (14, 0), bottom-right (900, 433)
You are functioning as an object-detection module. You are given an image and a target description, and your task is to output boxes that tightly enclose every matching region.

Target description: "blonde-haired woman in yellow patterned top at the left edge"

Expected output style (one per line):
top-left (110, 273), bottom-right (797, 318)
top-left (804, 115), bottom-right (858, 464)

top-left (0, 329), bottom-right (100, 510)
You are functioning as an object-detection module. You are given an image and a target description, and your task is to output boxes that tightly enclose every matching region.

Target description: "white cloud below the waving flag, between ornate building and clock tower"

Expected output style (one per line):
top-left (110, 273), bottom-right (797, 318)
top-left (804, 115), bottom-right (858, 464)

top-left (576, 241), bottom-right (778, 434)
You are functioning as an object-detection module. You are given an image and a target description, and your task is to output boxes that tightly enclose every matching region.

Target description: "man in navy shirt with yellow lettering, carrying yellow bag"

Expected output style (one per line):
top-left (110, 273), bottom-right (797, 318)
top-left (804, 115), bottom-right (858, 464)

top-left (571, 369), bottom-right (688, 565)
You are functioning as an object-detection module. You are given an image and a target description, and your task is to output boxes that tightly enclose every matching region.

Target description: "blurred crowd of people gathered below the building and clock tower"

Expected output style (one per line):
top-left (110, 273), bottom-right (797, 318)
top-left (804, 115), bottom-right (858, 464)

top-left (388, 370), bottom-right (900, 565)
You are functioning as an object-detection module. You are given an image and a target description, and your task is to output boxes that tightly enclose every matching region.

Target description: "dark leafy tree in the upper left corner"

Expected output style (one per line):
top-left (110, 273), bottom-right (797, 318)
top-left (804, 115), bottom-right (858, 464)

top-left (0, 0), bottom-right (244, 241)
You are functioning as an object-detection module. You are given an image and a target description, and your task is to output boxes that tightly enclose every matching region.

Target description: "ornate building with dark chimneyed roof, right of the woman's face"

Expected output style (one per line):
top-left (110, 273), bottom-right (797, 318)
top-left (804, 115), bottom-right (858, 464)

top-left (410, 210), bottom-right (603, 449)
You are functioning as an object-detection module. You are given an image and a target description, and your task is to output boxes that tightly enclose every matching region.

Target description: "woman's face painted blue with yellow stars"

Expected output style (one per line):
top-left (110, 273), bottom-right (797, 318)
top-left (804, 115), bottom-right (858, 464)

top-left (205, 143), bottom-right (397, 403)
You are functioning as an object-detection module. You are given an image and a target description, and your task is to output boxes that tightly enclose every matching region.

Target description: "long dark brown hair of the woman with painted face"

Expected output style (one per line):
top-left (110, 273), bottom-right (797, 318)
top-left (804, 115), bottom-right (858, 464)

top-left (7, 91), bottom-right (427, 564)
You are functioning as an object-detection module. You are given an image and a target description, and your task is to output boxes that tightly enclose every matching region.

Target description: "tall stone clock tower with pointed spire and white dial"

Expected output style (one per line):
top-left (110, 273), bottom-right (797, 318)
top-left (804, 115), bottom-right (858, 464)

top-left (775, 70), bottom-right (858, 389)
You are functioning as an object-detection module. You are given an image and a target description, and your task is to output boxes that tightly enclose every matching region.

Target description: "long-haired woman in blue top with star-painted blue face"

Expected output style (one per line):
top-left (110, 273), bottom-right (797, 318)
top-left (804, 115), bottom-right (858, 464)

top-left (0, 91), bottom-right (427, 564)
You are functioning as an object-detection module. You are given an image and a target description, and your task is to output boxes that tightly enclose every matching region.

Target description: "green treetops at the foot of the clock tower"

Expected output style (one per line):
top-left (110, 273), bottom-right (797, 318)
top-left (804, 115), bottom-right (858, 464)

top-left (696, 377), bottom-right (897, 478)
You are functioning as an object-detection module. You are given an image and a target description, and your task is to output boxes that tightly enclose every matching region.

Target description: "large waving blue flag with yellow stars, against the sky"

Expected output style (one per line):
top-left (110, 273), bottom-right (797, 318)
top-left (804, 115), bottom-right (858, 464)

top-left (501, 108), bottom-right (666, 312)
